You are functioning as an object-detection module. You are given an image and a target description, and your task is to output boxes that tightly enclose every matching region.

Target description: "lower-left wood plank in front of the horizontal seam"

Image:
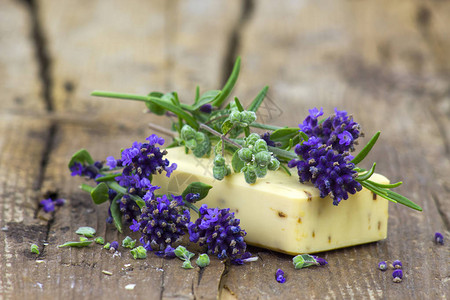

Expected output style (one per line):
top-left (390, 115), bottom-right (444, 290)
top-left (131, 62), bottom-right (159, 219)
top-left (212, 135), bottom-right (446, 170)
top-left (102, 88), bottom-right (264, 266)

top-left (0, 116), bottom-right (49, 299)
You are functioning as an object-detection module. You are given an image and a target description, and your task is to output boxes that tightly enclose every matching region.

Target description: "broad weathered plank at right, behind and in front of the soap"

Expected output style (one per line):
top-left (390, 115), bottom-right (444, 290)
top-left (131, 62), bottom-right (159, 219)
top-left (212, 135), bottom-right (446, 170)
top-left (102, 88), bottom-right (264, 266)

top-left (223, 1), bottom-right (450, 298)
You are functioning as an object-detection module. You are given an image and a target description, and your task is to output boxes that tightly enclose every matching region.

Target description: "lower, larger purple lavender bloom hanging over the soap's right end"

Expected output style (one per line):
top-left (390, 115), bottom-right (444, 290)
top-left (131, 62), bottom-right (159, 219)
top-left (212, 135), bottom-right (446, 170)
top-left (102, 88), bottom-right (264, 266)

top-left (288, 137), bottom-right (362, 205)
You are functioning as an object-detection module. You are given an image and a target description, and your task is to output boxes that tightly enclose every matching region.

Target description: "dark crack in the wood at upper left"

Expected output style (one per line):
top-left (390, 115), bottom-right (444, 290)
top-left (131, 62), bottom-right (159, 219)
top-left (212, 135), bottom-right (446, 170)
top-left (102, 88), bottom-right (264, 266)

top-left (21, 0), bottom-right (54, 112)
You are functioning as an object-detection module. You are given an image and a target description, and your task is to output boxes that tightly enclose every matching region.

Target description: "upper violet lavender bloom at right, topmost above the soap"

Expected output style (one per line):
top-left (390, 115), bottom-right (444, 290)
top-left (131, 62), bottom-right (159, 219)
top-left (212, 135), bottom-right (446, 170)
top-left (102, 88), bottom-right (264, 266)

top-left (299, 108), bottom-right (362, 153)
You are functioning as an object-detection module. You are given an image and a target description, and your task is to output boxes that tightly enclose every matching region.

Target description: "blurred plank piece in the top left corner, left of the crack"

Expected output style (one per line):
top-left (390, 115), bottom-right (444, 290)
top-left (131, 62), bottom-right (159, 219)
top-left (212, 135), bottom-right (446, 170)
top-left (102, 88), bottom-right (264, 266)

top-left (0, 0), bottom-right (45, 114)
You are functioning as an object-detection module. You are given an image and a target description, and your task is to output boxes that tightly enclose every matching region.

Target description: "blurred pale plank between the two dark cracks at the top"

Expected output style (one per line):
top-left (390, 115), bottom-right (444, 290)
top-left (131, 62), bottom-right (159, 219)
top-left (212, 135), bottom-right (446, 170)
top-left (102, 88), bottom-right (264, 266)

top-left (39, 0), bottom-right (239, 124)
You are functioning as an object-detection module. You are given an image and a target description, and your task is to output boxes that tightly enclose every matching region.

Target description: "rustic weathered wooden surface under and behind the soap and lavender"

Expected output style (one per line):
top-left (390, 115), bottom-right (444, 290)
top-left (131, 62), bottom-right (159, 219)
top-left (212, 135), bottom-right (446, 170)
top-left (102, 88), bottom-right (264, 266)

top-left (0, 0), bottom-right (450, 299)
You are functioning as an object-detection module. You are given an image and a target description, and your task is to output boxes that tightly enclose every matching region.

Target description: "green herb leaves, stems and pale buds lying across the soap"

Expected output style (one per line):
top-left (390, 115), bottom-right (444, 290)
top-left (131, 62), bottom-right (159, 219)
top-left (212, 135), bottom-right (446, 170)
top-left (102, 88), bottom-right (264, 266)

top-left (90, 58), bottom-right (422, 212)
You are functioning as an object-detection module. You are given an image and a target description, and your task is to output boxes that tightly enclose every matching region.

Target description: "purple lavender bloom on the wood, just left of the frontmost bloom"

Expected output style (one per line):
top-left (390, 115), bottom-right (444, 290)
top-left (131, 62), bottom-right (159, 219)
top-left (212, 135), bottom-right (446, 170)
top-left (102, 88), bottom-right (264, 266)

top-left (130, 195), bottom-right (190, 251)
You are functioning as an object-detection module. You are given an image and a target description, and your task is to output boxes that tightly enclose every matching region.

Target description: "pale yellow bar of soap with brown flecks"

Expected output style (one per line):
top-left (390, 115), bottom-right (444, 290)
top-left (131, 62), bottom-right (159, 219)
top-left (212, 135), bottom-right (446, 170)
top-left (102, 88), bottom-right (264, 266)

top-left (152, 148), bottom-right (389, 255)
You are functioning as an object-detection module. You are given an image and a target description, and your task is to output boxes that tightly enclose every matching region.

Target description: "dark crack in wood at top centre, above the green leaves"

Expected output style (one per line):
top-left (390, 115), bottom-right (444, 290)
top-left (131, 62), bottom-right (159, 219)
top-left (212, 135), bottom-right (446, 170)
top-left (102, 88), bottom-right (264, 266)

top-left (222, 0), bottom-right (255, 84)
